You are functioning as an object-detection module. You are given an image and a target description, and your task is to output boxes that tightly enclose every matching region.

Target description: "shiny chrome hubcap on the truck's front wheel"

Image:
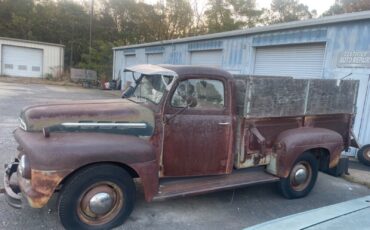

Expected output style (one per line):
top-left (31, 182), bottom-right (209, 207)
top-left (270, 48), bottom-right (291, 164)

top-left (89, 192), bottom-right (113, 215)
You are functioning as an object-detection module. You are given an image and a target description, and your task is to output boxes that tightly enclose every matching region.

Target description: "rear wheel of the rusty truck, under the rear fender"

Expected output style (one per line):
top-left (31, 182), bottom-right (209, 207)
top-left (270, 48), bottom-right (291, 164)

top-left (279, 152), bottom-right (318, 199)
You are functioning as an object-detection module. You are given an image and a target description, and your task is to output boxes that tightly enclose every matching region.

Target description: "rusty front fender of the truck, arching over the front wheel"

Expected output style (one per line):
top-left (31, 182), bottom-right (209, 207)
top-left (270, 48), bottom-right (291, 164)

top-left (14, 129), bottom-right (158, 205)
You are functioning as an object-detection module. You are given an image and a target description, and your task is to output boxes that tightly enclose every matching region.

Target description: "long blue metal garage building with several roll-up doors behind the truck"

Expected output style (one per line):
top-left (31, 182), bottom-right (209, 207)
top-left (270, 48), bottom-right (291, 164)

top-left (113, 11), bottom-right (370, 151)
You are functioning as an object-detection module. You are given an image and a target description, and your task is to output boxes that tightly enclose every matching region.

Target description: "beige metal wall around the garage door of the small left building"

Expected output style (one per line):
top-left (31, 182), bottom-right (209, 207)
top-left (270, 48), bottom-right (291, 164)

top-left (0, 39), bottom-right (64, 76)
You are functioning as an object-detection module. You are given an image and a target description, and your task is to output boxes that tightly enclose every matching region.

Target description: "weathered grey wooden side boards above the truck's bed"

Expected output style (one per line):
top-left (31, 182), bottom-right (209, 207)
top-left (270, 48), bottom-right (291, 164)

top-left (235, 76), bottom-right (359, 118)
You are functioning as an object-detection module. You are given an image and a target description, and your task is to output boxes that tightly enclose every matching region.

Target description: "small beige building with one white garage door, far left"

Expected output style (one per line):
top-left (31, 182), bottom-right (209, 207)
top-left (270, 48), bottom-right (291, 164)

top-left (0, 37), bottom-right (64, 78)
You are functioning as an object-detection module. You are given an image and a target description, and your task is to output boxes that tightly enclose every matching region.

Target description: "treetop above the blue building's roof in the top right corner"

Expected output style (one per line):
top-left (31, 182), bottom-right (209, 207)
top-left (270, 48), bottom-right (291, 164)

top-left (322, 0), bottom-right (370, 16)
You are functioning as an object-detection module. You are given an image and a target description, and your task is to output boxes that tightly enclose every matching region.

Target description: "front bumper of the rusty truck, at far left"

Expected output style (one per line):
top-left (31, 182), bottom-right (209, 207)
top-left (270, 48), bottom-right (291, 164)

top-left (4, 161), bottom-right (22, 208)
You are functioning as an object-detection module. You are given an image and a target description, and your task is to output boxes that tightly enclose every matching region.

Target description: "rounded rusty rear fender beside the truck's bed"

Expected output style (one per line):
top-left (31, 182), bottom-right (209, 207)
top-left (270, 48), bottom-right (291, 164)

top-left (267, 127), bottom-right (344, 178)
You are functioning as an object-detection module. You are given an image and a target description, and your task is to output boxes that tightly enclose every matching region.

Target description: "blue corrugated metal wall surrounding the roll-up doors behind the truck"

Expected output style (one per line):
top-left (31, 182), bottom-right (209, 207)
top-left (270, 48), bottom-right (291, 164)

top-left (114, 20), bottom-right (370, 147)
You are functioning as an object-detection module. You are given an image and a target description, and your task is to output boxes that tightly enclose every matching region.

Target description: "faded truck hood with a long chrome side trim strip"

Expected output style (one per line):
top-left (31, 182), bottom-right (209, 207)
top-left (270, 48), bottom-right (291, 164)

top-left (20, 99), bottom-right (154, 136)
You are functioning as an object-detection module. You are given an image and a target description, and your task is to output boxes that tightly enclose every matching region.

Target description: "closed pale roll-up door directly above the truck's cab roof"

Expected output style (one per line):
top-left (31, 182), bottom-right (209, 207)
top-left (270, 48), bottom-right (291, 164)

top-left (190, 50), bottom-right (222, 67)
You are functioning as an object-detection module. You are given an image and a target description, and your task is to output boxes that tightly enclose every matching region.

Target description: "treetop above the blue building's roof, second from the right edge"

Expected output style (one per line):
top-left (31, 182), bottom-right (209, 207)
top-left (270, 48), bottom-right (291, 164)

top-left (264, 0), bottom-right (316, 24)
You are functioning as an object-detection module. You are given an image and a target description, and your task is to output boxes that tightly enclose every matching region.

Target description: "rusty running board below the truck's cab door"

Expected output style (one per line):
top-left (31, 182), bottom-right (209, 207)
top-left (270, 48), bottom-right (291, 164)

top-left (153, 167), bottom-right (279, 201)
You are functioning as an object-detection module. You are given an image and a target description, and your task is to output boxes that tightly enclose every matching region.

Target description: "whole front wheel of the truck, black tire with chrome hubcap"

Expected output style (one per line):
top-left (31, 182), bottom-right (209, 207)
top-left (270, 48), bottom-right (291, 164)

top-left (58, 165), bottom-right (135, 229)
